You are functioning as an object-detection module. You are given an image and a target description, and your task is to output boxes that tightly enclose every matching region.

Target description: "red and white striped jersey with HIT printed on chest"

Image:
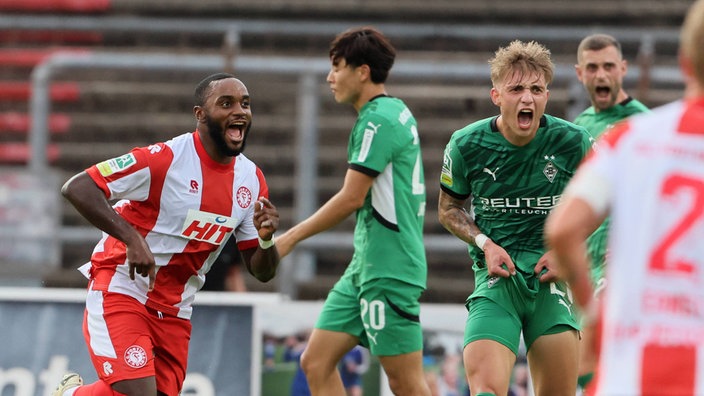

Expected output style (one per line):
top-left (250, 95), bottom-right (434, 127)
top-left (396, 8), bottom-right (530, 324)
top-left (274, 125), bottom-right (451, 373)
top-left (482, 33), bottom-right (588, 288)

top-left (81, 132), bottom-right (269, 319)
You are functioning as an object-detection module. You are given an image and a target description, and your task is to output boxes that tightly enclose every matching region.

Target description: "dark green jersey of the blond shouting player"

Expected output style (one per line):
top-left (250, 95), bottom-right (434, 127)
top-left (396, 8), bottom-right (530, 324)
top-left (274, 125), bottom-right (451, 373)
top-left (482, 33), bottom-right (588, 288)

top-left (440, 115), bottom-right (593, 290)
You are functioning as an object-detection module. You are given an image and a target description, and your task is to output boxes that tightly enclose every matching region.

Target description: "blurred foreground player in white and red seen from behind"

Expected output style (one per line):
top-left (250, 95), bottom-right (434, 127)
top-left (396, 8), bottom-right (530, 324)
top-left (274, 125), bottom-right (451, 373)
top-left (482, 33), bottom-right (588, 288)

top-left (546, 0), bottom-right (704, 396)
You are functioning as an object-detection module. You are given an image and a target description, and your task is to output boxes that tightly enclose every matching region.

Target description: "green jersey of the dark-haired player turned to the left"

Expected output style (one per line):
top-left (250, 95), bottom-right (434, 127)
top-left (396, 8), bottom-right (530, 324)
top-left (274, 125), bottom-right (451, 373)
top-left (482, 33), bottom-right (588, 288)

top-left (345, 96), bottom-right (427, 288)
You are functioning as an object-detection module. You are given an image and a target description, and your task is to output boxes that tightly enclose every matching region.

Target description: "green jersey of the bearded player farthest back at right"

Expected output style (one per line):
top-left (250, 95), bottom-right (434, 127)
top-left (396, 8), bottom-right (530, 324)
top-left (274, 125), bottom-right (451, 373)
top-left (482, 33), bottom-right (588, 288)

top-left (574, 97), bottom-right (650, 286)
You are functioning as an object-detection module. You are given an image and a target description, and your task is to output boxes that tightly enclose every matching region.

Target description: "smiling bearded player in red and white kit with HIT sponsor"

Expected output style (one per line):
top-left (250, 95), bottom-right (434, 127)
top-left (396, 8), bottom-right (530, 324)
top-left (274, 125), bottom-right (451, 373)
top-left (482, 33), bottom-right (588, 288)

top-left (54, 73), bottom-right (279, 396)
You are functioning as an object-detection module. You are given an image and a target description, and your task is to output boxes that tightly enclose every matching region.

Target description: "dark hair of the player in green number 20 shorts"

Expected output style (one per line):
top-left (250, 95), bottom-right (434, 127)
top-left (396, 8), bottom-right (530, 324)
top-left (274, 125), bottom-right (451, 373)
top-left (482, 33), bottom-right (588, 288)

top-left (330, 26), bottom-right (396, 84)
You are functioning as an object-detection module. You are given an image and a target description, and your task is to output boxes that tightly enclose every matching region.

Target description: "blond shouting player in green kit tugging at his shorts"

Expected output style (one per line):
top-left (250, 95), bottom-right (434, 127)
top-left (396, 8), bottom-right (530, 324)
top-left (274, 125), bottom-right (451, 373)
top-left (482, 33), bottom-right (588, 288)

top-left (438, 41), bottom-right (592, 396)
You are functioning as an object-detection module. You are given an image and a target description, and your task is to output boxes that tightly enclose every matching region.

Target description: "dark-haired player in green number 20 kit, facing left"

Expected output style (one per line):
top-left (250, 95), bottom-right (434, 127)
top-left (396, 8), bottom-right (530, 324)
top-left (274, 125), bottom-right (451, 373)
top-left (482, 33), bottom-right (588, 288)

top-left (277, 27), bottom-right (430, 396)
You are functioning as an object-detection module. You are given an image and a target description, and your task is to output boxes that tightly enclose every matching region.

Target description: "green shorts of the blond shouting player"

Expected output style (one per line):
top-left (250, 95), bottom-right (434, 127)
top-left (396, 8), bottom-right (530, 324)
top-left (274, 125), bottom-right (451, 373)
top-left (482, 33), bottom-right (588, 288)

top-left (464, 272), bottom-right (579, 354)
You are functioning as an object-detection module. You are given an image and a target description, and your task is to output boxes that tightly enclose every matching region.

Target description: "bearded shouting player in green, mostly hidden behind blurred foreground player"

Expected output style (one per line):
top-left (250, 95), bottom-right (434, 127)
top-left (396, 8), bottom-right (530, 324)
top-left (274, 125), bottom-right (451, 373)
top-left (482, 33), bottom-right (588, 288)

top-left (574, 33), bottom-right (649, 387)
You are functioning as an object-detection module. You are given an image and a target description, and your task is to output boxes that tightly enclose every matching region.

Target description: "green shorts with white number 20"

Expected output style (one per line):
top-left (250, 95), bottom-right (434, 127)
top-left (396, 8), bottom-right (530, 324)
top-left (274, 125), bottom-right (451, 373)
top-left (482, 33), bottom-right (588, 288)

top-left (315, 276), bottom-right (423, 356)
